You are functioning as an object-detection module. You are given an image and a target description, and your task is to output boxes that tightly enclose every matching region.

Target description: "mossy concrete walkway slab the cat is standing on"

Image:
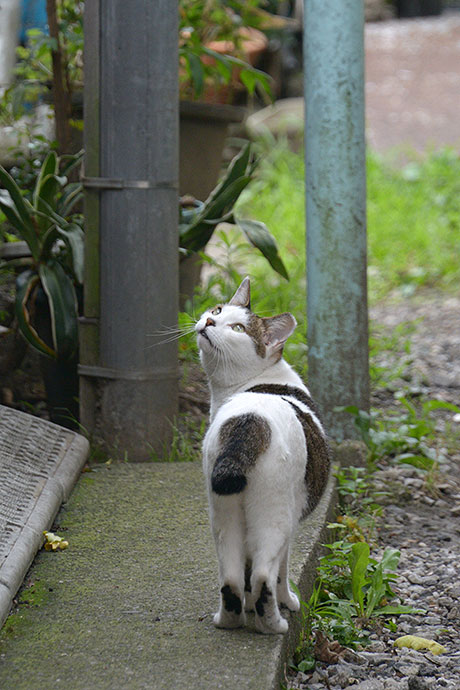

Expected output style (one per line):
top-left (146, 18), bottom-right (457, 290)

top-left (0, 463), bottom-right (333, 690)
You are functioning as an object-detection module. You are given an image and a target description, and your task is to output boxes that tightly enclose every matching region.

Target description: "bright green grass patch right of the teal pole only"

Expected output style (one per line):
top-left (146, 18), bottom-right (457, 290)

top-left (367, 149), bottom-right (460, 296)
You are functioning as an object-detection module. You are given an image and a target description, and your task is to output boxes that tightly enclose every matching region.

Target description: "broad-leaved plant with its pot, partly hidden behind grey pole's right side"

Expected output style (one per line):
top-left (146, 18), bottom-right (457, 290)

top-left (179, 142), bottom-right (289, 305)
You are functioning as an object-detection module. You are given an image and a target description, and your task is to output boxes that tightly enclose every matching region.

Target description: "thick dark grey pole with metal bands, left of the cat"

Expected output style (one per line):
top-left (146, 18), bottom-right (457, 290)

top-left (80, 0), bottom-right (178, 461)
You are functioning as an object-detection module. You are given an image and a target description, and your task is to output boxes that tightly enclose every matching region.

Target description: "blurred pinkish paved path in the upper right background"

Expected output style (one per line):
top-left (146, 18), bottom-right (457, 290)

top-left (366, 11), bottom-right (460, 152)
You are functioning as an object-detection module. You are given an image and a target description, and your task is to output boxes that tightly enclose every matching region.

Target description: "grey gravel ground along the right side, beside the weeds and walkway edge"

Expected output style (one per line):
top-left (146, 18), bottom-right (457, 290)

top-left (288, 295), bottom-right (460, 690)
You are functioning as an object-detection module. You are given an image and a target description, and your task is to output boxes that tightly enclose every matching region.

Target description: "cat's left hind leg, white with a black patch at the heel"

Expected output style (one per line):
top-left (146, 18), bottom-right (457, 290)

top-left (212, 495), bottom-right (246, 628)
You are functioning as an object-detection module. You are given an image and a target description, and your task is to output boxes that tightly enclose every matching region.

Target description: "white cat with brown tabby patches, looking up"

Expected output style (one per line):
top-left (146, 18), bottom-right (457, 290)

top-left (195, 278), bottom-right (330, 634)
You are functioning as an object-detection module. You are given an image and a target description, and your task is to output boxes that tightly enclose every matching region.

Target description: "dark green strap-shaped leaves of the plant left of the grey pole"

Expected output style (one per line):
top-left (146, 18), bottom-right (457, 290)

top-left (0, 151), bottom-right (83, 359)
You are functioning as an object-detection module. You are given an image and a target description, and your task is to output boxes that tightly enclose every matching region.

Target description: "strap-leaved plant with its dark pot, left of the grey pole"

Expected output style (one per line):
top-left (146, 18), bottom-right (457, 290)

top-left (0, 151), bottom-right (83, 426)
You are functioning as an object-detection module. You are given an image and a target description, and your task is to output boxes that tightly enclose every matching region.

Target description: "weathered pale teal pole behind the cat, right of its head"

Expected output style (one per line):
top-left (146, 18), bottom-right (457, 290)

top-left (304, 0), bottom-right (369, 441)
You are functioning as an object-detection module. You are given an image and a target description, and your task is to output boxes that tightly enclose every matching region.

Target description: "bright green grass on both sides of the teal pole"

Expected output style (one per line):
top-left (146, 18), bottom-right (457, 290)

top-left (240, 139), bottom-right (460, 300)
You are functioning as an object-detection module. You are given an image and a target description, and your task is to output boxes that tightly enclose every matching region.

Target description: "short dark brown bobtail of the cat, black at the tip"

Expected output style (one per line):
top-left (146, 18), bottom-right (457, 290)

top-left (211, 412), bottom-right (271, 496)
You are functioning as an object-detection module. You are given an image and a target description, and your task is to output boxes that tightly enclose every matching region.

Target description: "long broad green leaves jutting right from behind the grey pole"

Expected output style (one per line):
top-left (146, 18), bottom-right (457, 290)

top-left (179, 143), bottom-right (288, 279)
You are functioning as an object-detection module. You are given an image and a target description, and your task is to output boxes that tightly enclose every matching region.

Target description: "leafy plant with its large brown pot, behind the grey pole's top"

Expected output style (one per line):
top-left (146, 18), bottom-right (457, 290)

top-left (179, 0), bottom-right (272, 199)
